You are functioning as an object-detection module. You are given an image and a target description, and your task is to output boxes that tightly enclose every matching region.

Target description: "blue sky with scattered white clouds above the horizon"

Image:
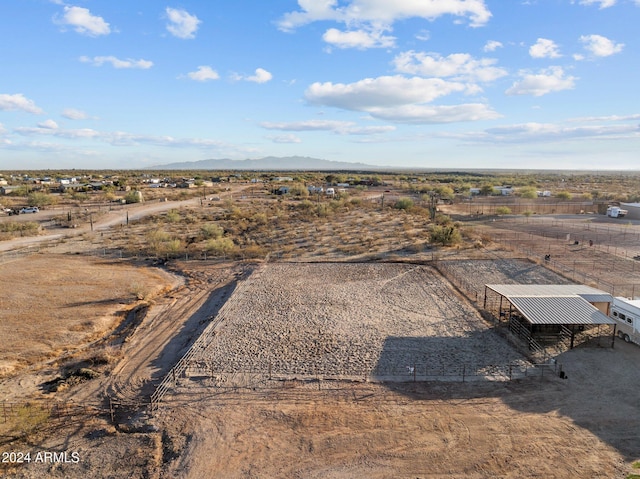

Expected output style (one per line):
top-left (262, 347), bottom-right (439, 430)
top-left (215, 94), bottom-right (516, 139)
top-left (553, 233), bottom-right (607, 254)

top-left (0, 0), bottom-right (640, 170)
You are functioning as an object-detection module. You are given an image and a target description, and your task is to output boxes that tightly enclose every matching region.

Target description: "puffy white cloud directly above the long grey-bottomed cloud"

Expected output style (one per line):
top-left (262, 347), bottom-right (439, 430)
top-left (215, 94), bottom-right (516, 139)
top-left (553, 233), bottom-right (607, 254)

top-left (393, 50), bottom-right (507, 82)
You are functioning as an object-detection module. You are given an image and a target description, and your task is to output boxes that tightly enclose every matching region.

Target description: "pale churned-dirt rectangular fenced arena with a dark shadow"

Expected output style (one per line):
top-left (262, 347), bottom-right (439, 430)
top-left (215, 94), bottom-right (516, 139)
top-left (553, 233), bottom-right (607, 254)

top-left (190, 263), bottom-right (528, 381)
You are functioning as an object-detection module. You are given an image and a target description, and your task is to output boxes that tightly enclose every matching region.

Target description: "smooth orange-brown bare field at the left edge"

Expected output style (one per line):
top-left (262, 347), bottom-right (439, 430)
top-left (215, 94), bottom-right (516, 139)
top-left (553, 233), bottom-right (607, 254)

top-left (0, 254), bottom-right (180, 377)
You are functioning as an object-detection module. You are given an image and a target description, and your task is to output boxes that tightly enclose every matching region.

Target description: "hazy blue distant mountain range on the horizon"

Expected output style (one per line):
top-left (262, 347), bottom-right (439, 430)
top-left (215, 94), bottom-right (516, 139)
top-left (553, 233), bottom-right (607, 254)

top-left (147, 156), bottom-right (382, 171)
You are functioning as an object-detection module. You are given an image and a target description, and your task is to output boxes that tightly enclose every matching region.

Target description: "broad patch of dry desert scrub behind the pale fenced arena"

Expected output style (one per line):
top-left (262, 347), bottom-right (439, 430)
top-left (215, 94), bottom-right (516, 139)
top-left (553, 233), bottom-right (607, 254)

top-left (121, 195), bottom-right (476, 259)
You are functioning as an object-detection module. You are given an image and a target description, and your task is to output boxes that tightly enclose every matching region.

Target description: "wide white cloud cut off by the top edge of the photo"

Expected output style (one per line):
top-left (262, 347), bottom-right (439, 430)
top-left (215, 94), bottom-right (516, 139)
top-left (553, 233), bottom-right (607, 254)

top-left (278, 0), bottom-right (491, 31)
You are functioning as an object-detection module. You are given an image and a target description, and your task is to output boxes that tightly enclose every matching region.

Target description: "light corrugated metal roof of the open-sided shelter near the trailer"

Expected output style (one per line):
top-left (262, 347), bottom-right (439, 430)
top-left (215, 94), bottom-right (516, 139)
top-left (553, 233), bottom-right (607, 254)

top-left (486, 284), bottom-right (615, 324)
